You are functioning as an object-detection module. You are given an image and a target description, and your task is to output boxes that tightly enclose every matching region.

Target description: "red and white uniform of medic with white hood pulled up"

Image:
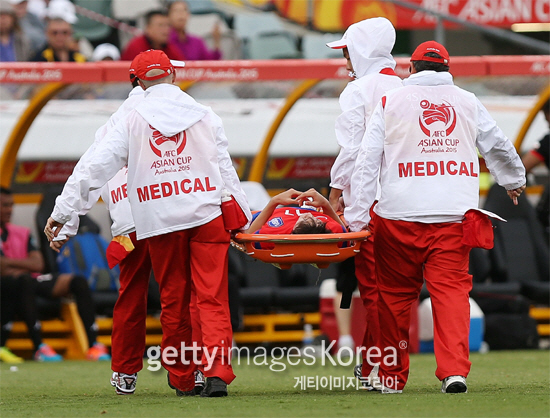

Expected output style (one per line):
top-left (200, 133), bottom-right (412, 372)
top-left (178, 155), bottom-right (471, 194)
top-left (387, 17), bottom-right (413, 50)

top-left (330, 18), bottom-right (402, 376)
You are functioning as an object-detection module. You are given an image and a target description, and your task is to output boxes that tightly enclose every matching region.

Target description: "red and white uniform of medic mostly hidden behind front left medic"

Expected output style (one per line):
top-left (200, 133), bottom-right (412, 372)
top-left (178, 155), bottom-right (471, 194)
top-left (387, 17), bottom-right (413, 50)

top-left (57, 87), bottom-right (151, 374)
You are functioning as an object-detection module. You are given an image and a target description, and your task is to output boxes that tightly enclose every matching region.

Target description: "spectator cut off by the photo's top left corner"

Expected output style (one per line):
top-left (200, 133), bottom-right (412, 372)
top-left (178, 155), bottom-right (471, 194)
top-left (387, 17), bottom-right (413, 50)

top-left (0, 0), bottom-right (32, 62)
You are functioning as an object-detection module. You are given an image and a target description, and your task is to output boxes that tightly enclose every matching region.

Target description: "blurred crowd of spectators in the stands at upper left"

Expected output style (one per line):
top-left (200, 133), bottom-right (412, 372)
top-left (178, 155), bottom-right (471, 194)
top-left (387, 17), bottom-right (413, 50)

top-left (0, 0), bottom-right (222, 62)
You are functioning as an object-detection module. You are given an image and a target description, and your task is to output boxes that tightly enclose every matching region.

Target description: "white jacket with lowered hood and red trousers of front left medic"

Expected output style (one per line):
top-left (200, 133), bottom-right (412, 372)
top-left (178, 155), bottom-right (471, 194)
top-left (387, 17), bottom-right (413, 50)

top-left (52, 84), bottom-right (251, 391)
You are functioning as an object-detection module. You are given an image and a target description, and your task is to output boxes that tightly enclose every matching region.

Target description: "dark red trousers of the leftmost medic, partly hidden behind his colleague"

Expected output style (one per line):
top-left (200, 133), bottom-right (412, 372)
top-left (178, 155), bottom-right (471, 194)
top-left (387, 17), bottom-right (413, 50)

top-left (111, 232), bottom-right (151, 374)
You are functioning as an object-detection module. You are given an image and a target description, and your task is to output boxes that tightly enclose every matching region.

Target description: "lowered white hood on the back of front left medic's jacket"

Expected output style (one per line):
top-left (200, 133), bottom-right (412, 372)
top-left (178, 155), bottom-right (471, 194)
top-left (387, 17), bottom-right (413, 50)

top-left (136, 84), bottom-right (208, 137)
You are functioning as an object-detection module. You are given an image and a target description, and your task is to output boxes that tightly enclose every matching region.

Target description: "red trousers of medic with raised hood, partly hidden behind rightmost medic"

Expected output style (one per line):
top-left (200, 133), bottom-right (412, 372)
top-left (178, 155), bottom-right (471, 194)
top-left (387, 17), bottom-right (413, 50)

top-left (355, 209), bottom-right (380, 377)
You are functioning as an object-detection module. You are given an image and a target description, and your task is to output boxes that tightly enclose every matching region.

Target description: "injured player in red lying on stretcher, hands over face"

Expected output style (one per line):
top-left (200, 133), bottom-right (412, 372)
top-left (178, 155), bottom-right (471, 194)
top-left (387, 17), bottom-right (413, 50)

top-left (246, 189), bottom-right (347, 234)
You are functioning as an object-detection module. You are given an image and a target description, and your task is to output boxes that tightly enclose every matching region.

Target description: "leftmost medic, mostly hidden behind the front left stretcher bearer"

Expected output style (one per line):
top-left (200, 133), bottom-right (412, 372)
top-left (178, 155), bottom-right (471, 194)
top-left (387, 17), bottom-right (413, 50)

top-left (50, 70), bottom-right (204, 395)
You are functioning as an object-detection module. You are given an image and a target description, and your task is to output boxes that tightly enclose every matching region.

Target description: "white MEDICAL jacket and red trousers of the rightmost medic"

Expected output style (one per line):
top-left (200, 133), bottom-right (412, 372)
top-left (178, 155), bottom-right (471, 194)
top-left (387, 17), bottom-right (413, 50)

top-left (345, 71), bottom-right (525, 390)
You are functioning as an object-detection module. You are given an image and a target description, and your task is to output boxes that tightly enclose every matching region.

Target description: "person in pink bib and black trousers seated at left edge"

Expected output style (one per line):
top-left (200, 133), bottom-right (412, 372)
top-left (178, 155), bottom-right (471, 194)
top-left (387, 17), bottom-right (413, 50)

top-left (0, 187), bottom-right (110, 361)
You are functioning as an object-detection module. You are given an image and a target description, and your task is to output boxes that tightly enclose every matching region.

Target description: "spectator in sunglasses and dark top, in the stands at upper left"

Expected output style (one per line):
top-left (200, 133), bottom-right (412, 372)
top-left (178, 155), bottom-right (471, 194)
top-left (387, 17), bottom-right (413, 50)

top-left (31, 17), bottom-right (86, 62)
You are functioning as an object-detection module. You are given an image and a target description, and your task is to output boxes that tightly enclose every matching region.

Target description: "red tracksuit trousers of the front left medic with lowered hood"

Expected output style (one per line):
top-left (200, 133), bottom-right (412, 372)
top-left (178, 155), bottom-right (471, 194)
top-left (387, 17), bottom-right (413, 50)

top-left (146, 216), bottom-right (235, 391)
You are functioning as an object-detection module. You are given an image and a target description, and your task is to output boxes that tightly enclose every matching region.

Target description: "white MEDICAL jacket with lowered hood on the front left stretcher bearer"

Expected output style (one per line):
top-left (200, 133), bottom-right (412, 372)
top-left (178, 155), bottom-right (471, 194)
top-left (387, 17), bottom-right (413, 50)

top-left (52, 84), bottom-right (251, 239)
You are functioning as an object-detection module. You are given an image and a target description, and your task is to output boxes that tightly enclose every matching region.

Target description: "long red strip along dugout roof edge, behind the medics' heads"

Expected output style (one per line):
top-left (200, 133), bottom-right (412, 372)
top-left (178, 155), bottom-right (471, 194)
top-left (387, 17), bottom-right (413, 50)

top-left (0, 55), bottom-right (550, 83)
